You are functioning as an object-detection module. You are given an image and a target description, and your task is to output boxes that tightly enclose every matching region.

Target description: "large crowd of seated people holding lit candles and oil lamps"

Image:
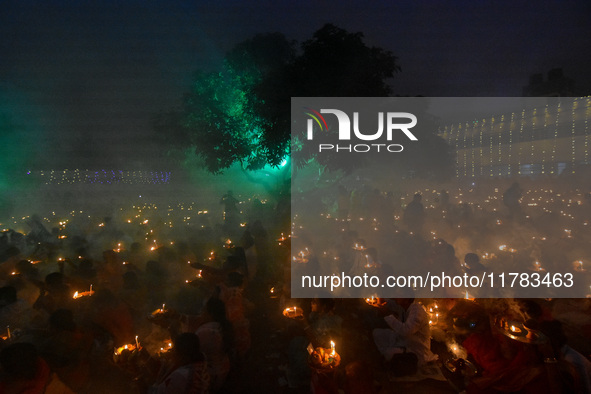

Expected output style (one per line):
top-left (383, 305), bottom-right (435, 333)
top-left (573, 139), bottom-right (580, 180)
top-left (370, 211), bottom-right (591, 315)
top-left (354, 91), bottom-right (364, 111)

top-left (0, 180), bottom-right (591, 393)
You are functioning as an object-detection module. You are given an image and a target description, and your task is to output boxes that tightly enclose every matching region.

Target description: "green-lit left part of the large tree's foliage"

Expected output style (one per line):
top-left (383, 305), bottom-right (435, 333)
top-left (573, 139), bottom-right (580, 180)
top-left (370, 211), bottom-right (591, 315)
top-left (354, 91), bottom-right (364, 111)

top-left (156, 33), bottom-right (294, 173)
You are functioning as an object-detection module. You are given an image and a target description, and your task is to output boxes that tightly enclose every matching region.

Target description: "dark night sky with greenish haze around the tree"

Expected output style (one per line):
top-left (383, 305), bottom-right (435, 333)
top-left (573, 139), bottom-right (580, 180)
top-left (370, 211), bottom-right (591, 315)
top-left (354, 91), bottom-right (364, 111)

top-left (0, 0), bottom-right (591, 169)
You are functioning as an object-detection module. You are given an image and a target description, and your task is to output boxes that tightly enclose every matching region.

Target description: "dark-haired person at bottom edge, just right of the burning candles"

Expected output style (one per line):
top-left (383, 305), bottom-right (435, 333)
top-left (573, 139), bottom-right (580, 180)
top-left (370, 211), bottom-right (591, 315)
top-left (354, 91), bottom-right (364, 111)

top-left (150, 332), bottom-right (210, 394)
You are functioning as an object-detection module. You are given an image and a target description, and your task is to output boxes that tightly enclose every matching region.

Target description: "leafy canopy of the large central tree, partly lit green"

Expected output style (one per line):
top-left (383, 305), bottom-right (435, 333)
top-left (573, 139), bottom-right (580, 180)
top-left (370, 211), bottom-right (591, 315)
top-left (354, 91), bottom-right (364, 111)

top-left (156, 24), bottom-right (454, 179)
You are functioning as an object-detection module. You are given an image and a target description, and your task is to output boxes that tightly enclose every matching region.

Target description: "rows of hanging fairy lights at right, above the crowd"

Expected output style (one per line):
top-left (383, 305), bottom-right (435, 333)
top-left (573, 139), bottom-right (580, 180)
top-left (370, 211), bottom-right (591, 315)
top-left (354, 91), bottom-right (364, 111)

top-left (439, 97), bottom-right (591, 178)
